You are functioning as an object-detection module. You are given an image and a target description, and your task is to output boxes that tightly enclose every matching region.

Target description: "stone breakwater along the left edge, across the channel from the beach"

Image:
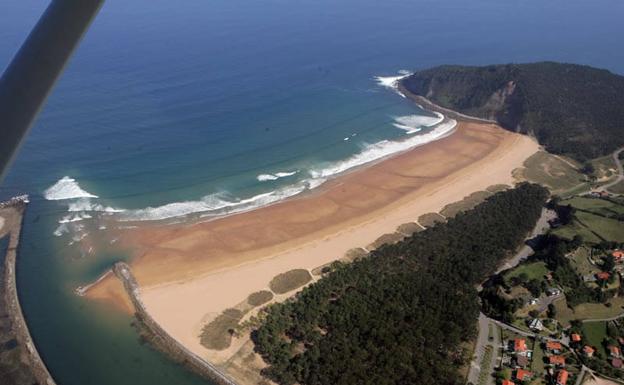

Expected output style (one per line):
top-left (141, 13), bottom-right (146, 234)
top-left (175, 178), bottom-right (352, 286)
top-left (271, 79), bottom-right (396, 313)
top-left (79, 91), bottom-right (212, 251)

top-left (0, 195), bottom-right (56, 385)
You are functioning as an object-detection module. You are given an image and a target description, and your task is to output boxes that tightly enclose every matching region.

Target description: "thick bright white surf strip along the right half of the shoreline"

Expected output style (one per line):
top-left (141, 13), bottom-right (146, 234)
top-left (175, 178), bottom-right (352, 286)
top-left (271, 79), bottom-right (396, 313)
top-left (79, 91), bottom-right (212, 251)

top-left (310, 120), bottom-right (457, 178)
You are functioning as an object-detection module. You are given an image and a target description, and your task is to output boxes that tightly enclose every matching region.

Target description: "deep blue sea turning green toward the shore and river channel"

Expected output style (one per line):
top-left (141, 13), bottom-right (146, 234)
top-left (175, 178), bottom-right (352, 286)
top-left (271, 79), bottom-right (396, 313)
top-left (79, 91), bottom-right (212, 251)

top-left (0, 0), bottom-right (624, 385)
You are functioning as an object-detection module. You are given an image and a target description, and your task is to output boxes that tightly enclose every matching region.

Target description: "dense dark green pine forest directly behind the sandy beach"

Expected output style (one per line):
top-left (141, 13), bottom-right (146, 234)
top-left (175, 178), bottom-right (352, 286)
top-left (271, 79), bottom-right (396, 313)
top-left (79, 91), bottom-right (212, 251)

top-left (252, 183), bottom-right (548, 385)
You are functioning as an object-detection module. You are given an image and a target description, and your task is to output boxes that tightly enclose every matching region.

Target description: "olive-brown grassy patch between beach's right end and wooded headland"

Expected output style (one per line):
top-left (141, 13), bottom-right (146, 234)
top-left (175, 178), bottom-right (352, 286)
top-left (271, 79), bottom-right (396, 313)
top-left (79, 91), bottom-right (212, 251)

top-left (518, 151), bottom-right (586, 194)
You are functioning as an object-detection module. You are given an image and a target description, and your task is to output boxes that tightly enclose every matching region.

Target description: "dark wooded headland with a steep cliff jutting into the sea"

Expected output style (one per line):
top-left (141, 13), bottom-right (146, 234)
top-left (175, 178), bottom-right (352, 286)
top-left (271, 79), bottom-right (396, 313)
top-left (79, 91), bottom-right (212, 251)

top-left (401, 62), bottom-right (624, 161)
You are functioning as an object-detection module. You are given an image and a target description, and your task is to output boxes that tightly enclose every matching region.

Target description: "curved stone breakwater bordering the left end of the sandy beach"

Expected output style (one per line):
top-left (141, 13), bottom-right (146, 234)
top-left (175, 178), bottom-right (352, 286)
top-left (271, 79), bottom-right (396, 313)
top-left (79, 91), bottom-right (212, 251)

top-left (113, 262), bottom-right (237, 385)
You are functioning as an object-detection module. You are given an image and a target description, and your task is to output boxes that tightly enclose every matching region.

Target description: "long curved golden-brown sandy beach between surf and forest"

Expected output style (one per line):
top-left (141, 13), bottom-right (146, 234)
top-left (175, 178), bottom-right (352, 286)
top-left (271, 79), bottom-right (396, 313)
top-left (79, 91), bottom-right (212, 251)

top-left (87, 122), bottom-right (539, 380)
